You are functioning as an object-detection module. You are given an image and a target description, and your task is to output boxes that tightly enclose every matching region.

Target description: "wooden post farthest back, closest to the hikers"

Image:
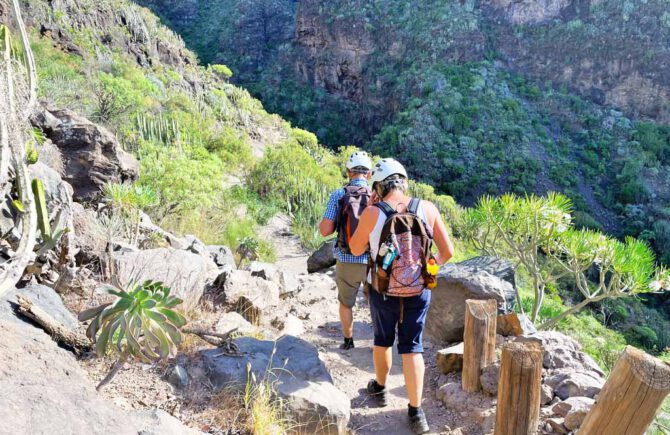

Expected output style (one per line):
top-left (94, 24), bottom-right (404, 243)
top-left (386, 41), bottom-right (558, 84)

top-left (463, 299), bottom-right (498, 392)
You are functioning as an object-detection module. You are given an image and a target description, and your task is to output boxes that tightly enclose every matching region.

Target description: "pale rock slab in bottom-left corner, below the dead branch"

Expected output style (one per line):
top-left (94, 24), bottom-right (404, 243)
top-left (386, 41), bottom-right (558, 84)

top-left (0, 285), bottom-right (199, 435)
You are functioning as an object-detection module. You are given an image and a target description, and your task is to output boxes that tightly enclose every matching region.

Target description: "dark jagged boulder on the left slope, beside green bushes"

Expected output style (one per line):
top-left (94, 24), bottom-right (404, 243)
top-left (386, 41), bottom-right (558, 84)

top-left (33, 108), bottom-right (139, 202)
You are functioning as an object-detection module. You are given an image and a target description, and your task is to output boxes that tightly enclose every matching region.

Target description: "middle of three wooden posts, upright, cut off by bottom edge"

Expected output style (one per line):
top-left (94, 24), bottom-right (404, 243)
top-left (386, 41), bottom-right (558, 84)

top-left (494, 342), bottom-right (544, 435)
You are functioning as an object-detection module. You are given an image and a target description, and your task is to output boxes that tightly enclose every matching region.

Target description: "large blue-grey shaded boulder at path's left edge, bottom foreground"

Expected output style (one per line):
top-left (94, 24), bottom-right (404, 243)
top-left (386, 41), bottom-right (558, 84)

top-left (202, 336), bottom-right (351, 434)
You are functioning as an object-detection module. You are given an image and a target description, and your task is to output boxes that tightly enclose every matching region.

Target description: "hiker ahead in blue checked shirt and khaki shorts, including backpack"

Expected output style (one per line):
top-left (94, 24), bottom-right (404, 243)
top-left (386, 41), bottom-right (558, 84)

top-left (319, 151), bottom-right (372, 350)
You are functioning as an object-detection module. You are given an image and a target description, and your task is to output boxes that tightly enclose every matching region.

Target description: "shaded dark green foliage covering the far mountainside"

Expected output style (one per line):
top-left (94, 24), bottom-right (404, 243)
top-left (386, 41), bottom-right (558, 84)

top-left (140, 0), bottom-right (670, 270)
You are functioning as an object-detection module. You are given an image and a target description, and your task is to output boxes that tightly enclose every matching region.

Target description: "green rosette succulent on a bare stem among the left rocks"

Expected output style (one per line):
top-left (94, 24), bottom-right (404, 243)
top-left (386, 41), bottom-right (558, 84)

top-left (79, 281), bottom-right (186, 390)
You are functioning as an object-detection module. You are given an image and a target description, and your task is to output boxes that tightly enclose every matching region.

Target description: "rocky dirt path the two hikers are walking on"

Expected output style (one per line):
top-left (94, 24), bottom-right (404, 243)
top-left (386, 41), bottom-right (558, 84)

top-left (263, 216), bottom-right (477, 435)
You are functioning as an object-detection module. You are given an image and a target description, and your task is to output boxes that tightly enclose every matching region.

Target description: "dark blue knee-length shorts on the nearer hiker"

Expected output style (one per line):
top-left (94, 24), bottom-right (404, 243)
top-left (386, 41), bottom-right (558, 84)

top-left (370, 290), bottom-right (431, 354)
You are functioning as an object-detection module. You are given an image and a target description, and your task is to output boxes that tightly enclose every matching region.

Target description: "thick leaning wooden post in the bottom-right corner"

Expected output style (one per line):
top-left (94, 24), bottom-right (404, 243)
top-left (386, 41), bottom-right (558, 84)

top-left (579, 346), bottom-right (670, 435)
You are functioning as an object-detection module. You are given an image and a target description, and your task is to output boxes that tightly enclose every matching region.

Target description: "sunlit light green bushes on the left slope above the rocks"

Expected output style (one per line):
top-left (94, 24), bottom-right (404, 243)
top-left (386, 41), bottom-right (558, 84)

top-left (33, 0), bottom-right (291, 259)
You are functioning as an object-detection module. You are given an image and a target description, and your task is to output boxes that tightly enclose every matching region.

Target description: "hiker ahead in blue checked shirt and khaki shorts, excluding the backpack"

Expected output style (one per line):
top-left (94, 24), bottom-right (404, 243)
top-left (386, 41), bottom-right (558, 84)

top-left (319, 151), bottom-right (372, 350)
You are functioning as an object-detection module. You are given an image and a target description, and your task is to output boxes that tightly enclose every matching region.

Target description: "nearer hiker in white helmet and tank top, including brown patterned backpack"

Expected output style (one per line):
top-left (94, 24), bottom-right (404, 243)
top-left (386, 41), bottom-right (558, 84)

top-left (349, 158), bottom-right (454, 434)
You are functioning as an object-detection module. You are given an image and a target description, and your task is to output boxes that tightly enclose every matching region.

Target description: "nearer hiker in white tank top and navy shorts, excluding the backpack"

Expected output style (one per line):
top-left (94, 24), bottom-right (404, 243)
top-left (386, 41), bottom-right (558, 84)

top-left (349, 159), bottom-right (454, 434)
